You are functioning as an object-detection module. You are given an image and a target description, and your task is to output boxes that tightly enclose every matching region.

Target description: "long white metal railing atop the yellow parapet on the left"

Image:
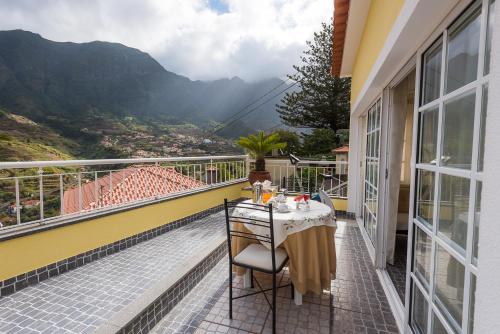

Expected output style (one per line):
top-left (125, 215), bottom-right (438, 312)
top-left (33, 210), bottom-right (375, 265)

top-left (0, 155), bottom-right (249, 229)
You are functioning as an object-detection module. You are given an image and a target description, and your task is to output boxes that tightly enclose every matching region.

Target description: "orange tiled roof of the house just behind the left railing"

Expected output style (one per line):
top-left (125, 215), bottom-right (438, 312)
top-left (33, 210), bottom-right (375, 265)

top-left (63, 166), bottom-right (205, 214)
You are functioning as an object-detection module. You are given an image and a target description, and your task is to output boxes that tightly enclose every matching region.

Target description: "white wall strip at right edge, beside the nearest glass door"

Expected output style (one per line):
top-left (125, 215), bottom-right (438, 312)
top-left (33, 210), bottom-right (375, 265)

top-left (474, 4), bottom-right (500, 334)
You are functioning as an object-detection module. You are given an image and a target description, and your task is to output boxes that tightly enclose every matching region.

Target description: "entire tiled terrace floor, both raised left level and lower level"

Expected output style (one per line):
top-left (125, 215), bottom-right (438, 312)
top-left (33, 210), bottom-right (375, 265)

top-left (0, 212), bottom-right (397, 334)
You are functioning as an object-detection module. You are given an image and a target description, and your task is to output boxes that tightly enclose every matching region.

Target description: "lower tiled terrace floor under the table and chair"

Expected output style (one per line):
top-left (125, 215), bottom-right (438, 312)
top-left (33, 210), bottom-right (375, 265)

top-left (152, 221), bottom-right (398, 334)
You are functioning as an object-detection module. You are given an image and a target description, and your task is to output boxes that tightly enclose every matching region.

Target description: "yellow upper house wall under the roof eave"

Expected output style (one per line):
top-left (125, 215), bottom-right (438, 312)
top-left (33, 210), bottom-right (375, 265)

top-left (351, 0), bottom-right (404, 104)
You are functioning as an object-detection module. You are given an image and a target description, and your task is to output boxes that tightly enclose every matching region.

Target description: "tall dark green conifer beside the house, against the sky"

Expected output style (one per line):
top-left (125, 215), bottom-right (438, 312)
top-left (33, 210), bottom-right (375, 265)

top-left (277, 23), bottom-right (351, 131)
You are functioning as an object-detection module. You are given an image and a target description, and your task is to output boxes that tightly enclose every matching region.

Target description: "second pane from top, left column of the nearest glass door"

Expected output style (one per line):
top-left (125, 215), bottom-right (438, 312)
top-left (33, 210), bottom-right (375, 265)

top-left (419, 108), bottom-right (439, 164)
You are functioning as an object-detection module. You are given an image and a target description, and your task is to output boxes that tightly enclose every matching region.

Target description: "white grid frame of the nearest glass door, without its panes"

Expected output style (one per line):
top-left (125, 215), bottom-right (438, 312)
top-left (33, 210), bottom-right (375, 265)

top-left (405, 0), bottom-right (490, 334)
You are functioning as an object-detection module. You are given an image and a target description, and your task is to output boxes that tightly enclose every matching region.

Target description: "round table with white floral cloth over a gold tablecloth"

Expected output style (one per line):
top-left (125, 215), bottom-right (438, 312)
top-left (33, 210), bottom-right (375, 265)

top-left (232, 197), bottom-right (337, 305)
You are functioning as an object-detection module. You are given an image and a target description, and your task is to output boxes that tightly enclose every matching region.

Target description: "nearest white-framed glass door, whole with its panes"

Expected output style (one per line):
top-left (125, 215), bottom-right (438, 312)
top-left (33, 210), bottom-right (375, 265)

top-left (408, 0), bottom-right (494, 333)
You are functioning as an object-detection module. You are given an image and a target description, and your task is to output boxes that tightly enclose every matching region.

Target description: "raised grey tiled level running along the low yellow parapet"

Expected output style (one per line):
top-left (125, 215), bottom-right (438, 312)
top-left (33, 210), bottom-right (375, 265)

top-left (0, 212), bottom-right (225, 334)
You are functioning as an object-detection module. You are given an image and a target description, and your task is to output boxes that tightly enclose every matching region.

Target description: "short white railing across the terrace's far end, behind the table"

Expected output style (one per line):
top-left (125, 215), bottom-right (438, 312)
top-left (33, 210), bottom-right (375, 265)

top-left (258, 159), bottom-right (349, 198)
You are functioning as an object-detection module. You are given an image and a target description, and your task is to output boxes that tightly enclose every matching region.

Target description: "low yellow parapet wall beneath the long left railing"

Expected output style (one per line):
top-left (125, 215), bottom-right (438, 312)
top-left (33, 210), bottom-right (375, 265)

top-left (0, 183), bottom-right (246, 281)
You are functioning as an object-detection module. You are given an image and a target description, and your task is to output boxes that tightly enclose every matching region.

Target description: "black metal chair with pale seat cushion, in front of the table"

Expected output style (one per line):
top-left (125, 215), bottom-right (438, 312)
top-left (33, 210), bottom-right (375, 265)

top-left (224, 199), bottom-right (294, 333)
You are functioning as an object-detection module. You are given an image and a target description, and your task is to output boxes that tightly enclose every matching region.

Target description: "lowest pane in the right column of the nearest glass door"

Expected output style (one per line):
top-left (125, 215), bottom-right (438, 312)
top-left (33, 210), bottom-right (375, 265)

top-left (434, 245), bottom-right (465, 327)
